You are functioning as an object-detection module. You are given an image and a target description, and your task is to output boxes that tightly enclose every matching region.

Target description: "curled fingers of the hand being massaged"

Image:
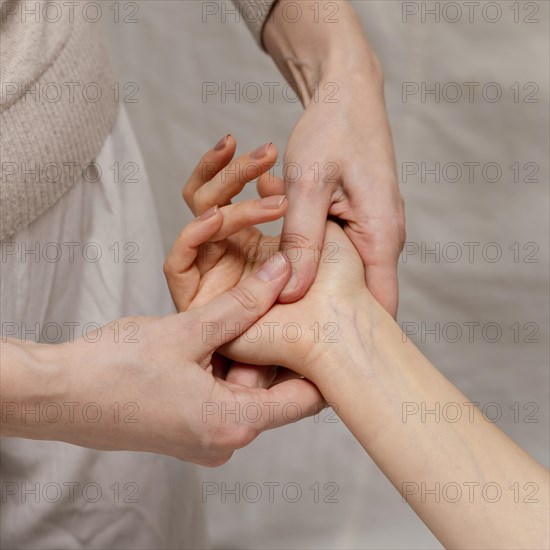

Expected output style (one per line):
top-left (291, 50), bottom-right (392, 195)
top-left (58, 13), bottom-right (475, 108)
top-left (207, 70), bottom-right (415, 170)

top-left (164, 135), bottom-right (298, 388)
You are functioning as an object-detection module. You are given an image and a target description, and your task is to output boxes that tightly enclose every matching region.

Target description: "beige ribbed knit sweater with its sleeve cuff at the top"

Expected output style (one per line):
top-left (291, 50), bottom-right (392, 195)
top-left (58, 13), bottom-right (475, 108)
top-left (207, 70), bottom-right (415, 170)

top-left (0, 0), bottom-right (276, 240)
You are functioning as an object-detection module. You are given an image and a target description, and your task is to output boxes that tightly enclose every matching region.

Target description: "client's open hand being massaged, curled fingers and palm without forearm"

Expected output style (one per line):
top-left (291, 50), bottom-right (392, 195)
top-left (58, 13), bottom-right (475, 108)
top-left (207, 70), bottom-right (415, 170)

top-left (165, 137), bottom-right (373, 379)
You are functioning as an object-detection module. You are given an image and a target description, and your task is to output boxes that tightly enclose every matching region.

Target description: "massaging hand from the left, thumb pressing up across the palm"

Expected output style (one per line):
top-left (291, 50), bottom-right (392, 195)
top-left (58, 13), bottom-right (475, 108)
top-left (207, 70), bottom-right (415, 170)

top-left (23, 254), bottom-right (323, 466)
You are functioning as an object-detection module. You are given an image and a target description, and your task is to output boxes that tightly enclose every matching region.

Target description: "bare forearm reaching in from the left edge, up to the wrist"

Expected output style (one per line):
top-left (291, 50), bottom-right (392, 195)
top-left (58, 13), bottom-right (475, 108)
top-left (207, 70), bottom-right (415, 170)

top-left (0, 333), bottom-right (138, 449)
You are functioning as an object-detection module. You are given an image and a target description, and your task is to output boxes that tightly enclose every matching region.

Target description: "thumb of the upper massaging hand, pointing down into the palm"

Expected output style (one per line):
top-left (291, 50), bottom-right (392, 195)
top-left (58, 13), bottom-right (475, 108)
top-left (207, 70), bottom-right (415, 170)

top-left (279, 183), bottom-right (331, 303)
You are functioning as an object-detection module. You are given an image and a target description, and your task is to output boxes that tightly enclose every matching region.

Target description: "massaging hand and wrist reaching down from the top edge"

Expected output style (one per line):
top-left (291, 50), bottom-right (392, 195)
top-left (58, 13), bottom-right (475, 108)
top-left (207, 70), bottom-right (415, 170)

top-left (263, 0), bottom-right (405, 317)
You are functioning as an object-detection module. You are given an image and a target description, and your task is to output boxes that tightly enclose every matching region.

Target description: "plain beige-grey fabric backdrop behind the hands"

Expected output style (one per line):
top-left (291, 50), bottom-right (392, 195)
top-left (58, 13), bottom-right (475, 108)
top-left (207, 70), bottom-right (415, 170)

top-left (104, 0), bottom-right (549, 548)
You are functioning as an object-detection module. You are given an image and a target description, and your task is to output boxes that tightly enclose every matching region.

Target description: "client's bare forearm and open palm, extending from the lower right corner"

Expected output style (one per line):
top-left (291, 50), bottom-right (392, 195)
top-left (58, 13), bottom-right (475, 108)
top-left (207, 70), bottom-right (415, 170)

top-left (167, 143), bottom-right (549, 549)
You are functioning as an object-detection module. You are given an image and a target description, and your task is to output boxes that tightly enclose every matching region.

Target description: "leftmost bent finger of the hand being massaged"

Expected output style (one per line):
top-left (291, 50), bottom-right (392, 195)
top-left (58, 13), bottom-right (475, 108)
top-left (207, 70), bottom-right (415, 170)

top-left (163, 207), bottom-right (223, 311)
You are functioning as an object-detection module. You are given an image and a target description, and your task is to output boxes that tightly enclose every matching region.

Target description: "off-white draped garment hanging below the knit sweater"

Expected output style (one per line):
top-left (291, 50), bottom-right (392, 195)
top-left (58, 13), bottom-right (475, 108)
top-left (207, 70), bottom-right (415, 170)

top-left (0, 109), bottom-right (206, 550)
